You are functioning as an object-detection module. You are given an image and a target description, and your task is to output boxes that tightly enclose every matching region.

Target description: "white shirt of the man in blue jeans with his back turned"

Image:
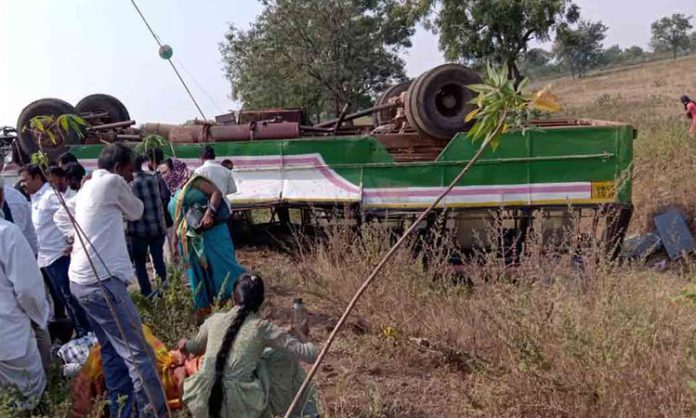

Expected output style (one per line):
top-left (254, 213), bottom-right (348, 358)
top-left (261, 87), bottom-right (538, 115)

top-left (54, 170), bottom-right (143, 285)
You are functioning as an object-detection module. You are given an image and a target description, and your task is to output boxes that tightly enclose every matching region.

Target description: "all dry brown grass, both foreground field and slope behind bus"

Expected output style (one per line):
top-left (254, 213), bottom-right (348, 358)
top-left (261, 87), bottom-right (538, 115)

top-left (14, 57), bottom-right (696, 418)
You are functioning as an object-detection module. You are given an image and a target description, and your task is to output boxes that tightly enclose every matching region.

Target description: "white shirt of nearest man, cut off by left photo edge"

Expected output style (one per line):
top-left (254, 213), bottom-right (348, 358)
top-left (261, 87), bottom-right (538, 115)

top-left (0, 219), bottom-right (49, 361)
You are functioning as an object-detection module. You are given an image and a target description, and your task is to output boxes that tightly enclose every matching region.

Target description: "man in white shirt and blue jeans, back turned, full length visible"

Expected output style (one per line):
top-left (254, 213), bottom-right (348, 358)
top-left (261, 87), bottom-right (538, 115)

top-left (55, 143), bottom-right (166, 418)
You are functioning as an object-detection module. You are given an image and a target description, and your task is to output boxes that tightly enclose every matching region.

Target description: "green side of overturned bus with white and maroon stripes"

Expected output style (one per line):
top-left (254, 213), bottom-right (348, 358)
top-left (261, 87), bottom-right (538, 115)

top-left (64, 122), bottom-right (635, 210)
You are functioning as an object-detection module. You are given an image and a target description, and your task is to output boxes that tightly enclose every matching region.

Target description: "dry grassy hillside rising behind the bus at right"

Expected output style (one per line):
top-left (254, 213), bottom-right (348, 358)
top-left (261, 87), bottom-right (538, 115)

top-left (532, 56), bottom-right (696, 233)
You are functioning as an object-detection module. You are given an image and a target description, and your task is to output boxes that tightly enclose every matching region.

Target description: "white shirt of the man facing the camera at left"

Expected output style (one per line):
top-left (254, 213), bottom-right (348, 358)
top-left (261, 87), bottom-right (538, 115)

top-left (31, 183), bottom-right (68, 268)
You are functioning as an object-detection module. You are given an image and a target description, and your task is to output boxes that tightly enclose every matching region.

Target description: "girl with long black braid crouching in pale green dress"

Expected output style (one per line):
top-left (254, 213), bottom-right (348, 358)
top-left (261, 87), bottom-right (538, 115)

top-left (179, 274), bottom-right (318, 418)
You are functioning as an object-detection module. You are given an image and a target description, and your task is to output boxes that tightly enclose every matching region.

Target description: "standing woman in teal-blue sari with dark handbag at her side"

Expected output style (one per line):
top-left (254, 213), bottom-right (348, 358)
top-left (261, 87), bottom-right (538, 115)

top-left (169, 175), bottom-right (246, 313)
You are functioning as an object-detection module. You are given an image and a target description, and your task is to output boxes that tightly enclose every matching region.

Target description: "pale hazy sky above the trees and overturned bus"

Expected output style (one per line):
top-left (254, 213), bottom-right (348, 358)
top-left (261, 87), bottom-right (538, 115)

top-left (0, 0), bottom-right (696, 125)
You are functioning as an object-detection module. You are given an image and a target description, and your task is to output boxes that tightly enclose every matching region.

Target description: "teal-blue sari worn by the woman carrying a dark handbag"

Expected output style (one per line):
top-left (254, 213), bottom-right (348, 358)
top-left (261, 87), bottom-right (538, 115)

top-left (169, 175), bottom-right (246, 310)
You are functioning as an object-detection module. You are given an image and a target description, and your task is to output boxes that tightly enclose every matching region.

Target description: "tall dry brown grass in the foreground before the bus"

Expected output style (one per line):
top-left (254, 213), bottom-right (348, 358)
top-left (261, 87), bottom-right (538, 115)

top-left (256, 228), bottom-right (696, 417)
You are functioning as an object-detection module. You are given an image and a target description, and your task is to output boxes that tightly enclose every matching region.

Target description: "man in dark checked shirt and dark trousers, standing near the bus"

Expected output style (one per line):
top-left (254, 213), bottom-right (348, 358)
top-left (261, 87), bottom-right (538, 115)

top-left (128, 157), bottom-right (167, 297)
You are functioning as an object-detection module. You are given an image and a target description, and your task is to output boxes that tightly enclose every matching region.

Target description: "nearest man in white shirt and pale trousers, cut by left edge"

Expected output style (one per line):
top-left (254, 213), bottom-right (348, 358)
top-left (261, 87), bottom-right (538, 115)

top-left (0, 179), bottom-right (49, 409)
